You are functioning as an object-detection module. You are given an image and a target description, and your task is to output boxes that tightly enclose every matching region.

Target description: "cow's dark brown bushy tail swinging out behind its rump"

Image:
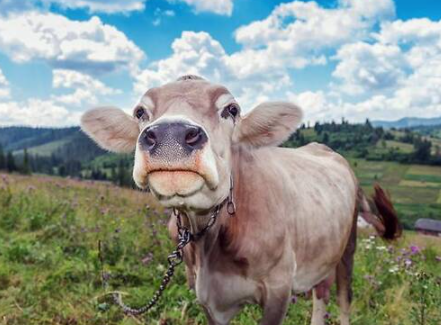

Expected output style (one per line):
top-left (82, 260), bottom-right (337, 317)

top-left (358, 184), bottom-right (402, 240)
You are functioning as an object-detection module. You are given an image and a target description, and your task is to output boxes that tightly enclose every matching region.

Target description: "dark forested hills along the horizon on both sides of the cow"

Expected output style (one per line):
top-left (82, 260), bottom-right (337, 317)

top-left (0, 120), bottom-right (441, 185)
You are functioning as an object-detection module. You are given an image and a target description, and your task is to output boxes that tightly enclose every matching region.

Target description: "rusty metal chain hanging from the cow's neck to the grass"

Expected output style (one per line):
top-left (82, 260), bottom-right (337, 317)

top-left (98, 176), bottom-right (236, 315)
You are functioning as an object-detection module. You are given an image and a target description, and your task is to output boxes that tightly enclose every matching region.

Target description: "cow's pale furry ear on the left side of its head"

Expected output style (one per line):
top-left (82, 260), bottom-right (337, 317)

top-left (81, 107), bottom-right (139, 152)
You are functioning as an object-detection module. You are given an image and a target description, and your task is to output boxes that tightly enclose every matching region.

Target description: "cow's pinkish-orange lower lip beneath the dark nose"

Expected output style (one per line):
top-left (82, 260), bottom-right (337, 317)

top-left (147, 170), bottom-right (205, 198)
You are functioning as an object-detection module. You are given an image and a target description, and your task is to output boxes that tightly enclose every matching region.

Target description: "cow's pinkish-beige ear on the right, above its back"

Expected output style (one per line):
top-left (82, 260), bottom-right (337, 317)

top-left (233, 102), bottom-right (303, 147)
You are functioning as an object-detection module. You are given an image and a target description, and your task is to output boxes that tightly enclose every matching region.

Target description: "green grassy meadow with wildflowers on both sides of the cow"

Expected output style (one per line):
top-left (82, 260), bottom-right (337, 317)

top-left (0, 171), bottom-right (441, 325)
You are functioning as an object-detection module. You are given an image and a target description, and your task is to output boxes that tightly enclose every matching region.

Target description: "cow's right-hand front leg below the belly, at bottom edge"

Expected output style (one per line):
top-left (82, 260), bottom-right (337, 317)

top-left (260, 285), bottom-right (291, 325)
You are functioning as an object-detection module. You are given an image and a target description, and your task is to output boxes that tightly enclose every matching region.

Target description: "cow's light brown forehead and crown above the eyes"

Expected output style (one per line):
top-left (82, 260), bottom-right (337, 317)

top-left (145, 75), bottom-right (232, 114)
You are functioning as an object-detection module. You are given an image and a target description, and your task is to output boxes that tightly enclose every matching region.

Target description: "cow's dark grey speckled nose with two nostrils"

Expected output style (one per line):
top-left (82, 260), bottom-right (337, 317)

top-left (140, 122), bottom-right (207, 153)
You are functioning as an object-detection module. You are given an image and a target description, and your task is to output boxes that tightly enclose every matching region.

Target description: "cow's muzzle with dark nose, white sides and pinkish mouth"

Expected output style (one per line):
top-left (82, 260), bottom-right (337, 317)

top-left (134, 121), bottom-right (219, 199)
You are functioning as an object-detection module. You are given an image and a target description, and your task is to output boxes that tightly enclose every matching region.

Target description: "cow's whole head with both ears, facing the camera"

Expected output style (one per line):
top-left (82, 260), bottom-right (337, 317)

top-left (81, 76), bottom-right (302, 210)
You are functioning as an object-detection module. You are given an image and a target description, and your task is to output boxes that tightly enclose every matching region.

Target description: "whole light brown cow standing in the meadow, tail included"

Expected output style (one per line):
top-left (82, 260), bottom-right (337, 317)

top-left (81, 75), bottom-right (401, 325)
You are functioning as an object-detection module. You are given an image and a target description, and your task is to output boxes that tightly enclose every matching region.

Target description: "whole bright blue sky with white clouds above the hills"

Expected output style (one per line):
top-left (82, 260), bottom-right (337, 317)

top-left (0, 0), bottom-right (441, 126)
